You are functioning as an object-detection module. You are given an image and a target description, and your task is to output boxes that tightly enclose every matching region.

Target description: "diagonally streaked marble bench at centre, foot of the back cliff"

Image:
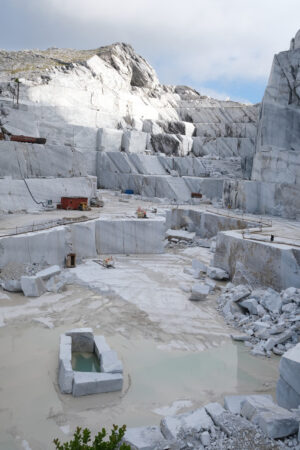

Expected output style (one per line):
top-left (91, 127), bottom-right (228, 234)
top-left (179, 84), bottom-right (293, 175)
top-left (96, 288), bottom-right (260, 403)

top-left (97, 152), bottom-right (226, 203)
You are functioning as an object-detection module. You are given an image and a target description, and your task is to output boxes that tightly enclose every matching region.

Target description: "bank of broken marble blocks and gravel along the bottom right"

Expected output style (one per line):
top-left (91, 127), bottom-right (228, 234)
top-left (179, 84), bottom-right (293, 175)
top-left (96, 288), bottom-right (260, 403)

top-left (124, 395), bottom-right (300, 450)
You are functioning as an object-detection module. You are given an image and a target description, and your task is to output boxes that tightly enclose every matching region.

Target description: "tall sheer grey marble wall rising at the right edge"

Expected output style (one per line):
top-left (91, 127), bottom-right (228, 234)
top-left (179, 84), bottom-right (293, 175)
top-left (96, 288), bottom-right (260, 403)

top-left (224, 31), bottom-right (300, 219)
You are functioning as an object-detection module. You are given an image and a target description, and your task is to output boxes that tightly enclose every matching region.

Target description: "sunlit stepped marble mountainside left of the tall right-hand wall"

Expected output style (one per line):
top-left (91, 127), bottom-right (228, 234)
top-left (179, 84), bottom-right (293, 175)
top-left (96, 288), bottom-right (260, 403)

top-left (0, 44), bottom-right (259, 211)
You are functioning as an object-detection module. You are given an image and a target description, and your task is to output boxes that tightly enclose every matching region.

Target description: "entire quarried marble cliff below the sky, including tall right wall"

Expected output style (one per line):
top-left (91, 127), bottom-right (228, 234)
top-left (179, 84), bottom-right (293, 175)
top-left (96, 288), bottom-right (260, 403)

top-left (0, 32), bottom-right (300, 218)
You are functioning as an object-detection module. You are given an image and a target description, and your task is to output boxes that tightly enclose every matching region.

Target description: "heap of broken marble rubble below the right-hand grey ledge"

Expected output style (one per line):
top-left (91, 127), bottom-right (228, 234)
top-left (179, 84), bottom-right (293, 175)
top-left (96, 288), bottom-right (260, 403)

top-left (218, 283), bottom-right (300, 356)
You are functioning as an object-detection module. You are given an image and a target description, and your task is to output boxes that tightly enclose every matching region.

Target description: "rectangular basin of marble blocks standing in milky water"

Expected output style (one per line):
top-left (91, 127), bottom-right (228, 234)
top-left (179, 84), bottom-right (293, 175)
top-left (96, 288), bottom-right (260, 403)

top-left (58, 328), bottom-right (123, 397)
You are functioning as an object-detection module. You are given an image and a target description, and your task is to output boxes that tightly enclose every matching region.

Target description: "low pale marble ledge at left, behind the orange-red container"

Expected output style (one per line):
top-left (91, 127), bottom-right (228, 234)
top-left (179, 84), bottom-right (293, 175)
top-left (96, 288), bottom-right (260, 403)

top-left (0, 177), bottom-right (96, 212)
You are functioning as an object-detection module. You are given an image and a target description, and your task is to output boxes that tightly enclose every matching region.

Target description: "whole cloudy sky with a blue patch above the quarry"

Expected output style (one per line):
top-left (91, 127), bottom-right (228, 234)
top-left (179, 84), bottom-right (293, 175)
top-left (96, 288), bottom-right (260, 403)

top-left (0, 0), bottom-right (300, 102)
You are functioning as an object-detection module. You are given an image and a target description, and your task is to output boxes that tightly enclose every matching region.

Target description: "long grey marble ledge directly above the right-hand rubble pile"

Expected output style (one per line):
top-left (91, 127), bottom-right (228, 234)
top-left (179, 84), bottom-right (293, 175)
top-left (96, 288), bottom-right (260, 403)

top-left (213, 231), bottom-right (300, 291)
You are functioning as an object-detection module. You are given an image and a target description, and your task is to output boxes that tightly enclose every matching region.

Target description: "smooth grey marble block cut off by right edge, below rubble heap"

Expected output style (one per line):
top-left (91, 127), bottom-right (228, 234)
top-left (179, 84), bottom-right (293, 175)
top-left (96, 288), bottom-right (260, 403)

top-left (276, 344), bottom-right (300, 409)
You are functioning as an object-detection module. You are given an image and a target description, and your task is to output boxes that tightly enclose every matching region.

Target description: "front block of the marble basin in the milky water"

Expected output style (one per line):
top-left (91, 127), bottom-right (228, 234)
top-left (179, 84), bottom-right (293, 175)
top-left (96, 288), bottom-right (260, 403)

top-left (72, 372), bottom-right (123, 397)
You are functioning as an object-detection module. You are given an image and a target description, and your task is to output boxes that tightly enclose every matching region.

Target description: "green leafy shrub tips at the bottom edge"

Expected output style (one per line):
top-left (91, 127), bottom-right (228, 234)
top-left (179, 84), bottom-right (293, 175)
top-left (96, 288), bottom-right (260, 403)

top-left (53, 425), bottom-right (131, 450)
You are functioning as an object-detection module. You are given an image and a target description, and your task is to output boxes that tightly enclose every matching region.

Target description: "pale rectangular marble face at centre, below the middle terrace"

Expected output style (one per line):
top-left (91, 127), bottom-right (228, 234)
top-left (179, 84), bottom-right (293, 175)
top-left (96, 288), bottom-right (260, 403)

top-left (96, 217), bottom-right (165, 255)
